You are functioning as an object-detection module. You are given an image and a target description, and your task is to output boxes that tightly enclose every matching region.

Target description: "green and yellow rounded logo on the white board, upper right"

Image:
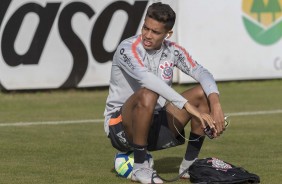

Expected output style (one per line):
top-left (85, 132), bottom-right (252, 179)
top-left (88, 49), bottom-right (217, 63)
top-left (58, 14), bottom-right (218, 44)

top-left (242, 0), bottom-right (282, 45)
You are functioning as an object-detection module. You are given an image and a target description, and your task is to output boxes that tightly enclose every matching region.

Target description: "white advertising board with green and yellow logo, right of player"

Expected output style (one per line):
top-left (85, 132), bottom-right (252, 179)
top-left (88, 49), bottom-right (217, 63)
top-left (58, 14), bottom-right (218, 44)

top-left (177, 0), bottom-right (282, 83)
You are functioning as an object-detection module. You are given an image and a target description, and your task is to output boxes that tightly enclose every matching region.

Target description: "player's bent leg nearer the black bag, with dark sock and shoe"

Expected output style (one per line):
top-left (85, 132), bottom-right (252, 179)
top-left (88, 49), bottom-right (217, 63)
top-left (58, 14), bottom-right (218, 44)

top-left (167, 86), bottom-right (210, 178)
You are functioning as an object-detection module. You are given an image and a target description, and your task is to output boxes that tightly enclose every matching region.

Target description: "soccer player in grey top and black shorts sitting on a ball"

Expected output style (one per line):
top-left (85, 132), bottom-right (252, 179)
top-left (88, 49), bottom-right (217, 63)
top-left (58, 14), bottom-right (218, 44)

top-left (104, 2), bottom-right (225, 183)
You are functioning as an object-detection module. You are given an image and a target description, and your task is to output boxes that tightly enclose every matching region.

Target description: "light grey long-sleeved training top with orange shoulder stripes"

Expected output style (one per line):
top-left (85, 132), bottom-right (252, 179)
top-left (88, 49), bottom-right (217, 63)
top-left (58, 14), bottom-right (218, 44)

top-left (104, 35), bottom-right (219, 135)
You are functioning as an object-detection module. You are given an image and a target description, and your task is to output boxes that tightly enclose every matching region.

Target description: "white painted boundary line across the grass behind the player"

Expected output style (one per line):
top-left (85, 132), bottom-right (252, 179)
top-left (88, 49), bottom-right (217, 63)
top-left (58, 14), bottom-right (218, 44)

top-left (0, 109), bottom-right (282, 127)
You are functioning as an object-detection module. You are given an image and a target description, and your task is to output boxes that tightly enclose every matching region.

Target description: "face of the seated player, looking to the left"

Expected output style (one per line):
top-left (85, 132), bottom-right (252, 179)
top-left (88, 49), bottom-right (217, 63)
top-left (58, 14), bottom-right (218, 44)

top-left (141, 17), bottom-right (168, 50)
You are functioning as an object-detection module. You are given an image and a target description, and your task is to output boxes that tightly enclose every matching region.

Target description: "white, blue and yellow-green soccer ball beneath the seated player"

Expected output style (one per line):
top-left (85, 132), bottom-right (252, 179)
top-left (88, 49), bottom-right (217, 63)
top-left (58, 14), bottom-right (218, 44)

top-left (114, 151), bottom-right (154, 179)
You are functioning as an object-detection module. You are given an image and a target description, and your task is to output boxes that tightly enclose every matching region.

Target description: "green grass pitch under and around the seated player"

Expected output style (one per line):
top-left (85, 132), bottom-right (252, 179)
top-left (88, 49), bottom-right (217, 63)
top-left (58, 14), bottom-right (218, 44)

top-left (0, 80), bottom-right (282, 184)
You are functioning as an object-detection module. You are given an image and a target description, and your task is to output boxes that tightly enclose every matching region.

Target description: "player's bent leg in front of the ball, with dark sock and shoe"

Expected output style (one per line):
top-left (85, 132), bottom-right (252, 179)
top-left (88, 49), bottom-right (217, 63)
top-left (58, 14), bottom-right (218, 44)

top-left (122, 88), bottom-right (163, 183)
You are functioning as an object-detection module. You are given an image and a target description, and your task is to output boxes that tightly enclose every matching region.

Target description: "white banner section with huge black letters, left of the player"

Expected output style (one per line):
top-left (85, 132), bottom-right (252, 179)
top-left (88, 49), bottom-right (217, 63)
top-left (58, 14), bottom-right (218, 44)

top-left (0, 0), bottom-right (148, 90)
